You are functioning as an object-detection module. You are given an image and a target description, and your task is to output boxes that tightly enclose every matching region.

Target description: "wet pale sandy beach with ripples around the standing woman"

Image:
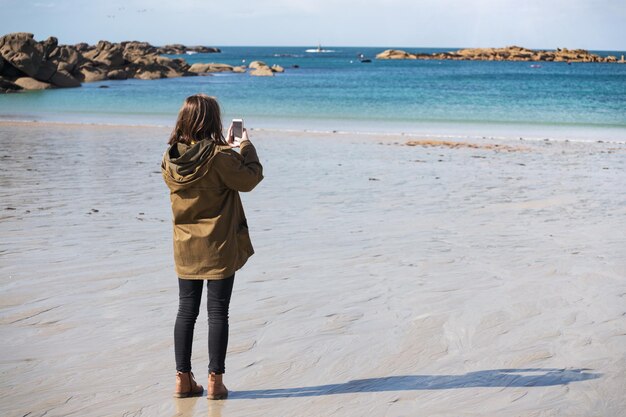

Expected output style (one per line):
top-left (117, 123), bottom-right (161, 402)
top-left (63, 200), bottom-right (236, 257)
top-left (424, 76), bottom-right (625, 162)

top-left (0, 122), bottom-right (626, 417)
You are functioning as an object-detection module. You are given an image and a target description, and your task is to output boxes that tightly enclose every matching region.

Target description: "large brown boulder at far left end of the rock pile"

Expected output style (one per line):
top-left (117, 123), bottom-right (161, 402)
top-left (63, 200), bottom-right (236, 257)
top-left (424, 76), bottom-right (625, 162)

top-left (0, 32), bottom-right (44, 77)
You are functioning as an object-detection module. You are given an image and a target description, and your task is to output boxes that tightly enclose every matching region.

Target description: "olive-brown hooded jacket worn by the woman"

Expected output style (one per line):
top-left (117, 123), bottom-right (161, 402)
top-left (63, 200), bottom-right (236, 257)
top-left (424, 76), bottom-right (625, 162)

top-left (161, 140), bottom-right (263, 279)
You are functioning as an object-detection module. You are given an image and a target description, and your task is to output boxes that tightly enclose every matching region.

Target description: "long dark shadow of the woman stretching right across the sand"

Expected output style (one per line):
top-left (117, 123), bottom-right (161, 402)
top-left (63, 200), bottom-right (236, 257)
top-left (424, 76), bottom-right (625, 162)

top-left (228, 368), bottom-right (602, 399)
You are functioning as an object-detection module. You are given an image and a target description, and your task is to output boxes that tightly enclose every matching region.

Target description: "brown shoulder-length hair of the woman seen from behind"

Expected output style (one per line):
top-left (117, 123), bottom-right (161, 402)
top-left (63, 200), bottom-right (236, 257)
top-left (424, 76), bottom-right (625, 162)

top-left (168, 94), bottom-right (226, 145)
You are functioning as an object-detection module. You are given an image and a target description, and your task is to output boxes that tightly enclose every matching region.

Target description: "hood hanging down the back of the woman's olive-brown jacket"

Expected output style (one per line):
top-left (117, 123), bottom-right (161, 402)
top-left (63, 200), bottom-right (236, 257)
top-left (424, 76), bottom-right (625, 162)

top-left (161, 140), bottom-right (221, 190)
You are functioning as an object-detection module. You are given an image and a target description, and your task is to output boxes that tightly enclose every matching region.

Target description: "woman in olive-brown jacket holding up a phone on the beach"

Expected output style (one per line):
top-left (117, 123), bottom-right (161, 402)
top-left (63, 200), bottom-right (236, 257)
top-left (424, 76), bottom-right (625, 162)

top-left (161, 94), bottom-right (263, 400)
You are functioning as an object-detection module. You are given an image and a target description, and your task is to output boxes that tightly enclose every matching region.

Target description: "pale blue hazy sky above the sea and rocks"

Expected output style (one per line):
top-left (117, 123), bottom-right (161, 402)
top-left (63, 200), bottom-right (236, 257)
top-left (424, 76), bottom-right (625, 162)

top-left (0, 0), bottom-right (626, 50)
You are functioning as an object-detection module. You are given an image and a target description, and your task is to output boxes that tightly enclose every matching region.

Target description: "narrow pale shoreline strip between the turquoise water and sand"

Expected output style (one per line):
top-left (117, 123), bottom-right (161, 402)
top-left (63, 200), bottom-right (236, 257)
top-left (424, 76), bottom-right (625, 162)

top-left (0, 119), bottom-right (626, 145)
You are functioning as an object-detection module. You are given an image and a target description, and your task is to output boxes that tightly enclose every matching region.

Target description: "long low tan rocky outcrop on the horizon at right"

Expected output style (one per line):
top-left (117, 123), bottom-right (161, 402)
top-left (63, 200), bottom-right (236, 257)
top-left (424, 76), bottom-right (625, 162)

top-left (376, 46), bottom-right (623, 63)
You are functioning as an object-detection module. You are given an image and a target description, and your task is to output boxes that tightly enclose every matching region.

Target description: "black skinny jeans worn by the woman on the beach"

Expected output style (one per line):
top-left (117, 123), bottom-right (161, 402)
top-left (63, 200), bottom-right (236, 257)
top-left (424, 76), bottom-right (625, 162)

top-left (174, 275), bottom-right (235, 374)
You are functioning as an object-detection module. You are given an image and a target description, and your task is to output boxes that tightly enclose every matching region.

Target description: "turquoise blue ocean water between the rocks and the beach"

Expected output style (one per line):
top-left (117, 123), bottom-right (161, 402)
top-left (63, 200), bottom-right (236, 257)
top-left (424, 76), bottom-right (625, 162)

top-left (0, 46), bottom-right (626, 140)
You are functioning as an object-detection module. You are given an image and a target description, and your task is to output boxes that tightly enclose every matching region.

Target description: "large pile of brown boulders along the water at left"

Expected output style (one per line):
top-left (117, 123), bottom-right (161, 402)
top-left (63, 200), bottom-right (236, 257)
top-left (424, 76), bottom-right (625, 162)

top-left (0, 33), bottom-right (224, 92)
